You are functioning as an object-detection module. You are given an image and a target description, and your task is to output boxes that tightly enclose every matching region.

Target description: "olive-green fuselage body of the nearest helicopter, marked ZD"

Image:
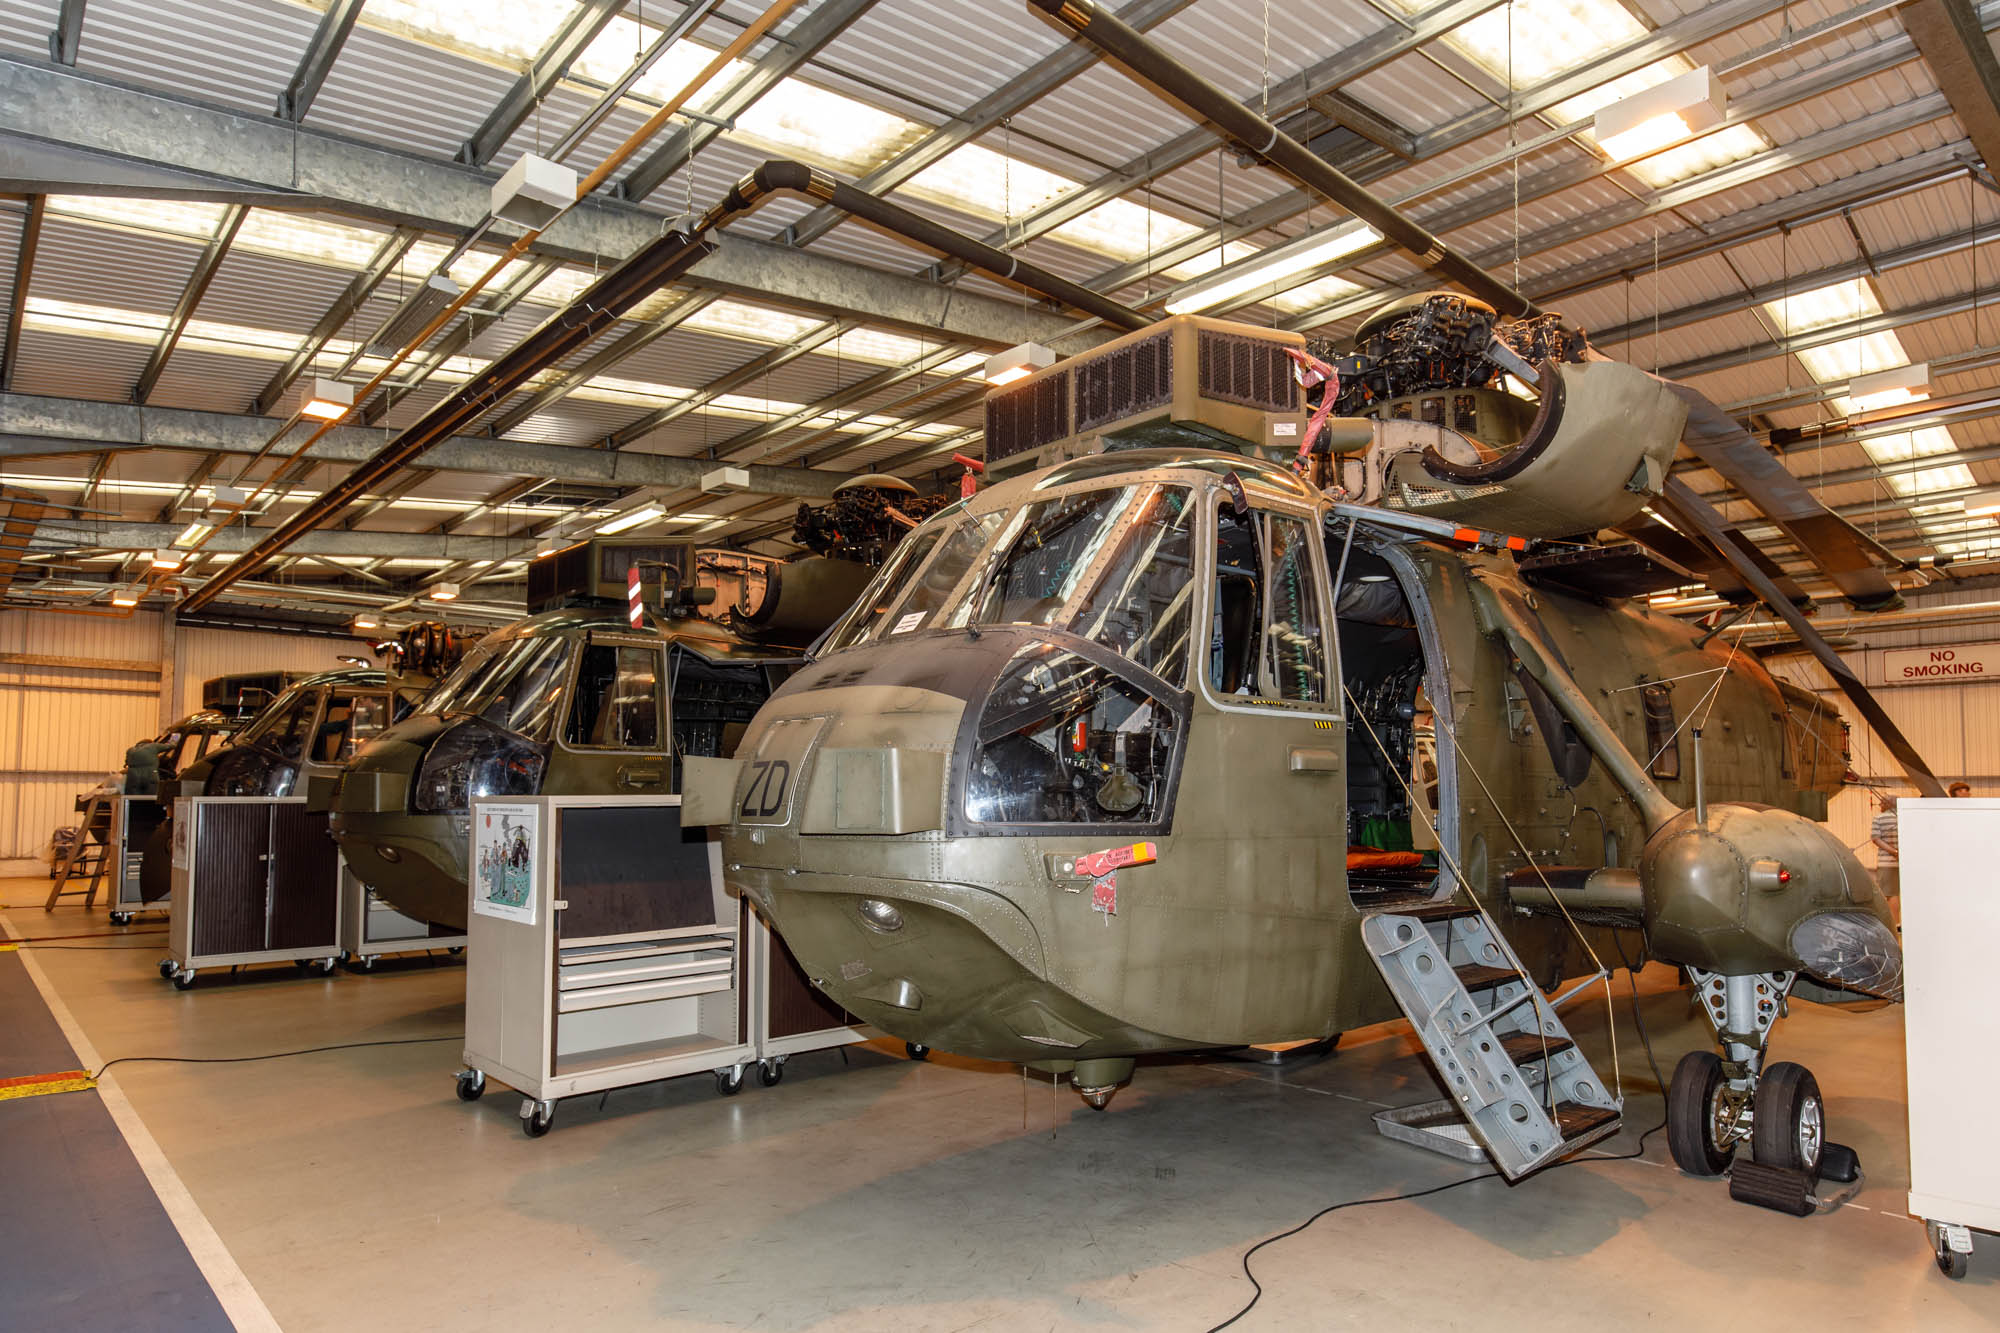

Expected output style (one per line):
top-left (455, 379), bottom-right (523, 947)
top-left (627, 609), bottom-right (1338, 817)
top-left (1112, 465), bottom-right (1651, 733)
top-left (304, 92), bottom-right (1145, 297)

top-left (690, 450), bottom-right (1872, 1077)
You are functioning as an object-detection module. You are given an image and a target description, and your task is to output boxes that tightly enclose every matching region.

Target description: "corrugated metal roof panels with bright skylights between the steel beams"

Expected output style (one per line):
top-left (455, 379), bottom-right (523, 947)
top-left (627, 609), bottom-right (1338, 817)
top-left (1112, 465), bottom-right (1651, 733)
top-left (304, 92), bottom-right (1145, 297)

top-left (0, 0), bottom-right (2000, 608)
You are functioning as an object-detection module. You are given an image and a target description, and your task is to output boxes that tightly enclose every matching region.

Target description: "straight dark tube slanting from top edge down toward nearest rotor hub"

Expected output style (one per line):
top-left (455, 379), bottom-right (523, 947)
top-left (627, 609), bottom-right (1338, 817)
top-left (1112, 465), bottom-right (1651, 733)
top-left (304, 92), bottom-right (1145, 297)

top-left (1028, 0), bottom-right (1540, 316)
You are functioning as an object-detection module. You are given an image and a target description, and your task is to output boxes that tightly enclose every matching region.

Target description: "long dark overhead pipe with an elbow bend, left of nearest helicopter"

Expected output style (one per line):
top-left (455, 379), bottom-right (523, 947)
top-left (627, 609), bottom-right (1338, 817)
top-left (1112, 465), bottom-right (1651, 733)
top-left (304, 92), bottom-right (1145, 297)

top-left (182, 158), bottom-right (1152, 610)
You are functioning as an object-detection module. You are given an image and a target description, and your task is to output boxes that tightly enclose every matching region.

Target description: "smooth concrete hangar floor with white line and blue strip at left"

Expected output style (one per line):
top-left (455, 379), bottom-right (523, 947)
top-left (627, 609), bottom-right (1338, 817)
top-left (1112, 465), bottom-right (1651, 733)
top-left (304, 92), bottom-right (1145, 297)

top-left (0, 879), bottom-right (2000, 1333)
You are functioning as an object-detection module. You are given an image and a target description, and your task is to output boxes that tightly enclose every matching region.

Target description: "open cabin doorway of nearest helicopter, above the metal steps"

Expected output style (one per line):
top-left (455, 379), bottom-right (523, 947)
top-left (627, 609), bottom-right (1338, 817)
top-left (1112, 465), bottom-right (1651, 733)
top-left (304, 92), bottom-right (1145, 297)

top-left (1334, 544), bottom-right (1454, 909)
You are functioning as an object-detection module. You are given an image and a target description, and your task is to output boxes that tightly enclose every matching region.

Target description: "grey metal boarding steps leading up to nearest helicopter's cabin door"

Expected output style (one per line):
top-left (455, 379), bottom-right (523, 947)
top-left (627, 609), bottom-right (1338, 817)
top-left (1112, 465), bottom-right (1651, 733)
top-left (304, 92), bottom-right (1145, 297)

top-left (1362, 903), bottom-right (1622, 1181)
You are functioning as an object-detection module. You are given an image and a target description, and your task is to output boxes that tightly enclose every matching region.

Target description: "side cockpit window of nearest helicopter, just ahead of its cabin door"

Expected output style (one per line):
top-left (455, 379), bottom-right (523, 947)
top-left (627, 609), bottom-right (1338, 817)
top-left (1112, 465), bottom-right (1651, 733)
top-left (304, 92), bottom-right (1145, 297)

top-left (1208, 504), bottom-right (1328, 703)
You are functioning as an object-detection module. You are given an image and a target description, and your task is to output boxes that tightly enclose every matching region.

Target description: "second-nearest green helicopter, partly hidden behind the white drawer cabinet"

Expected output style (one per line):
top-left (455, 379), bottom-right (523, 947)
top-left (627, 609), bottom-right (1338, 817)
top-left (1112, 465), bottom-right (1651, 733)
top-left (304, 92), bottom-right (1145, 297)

top-left (322, 536), bottom-right (870, 929)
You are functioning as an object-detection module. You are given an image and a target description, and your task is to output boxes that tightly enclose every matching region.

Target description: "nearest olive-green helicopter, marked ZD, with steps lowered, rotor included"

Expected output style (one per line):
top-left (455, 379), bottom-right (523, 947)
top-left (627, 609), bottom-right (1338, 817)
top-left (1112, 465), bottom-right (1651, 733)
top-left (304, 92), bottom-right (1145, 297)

top-left (684, 0), bottom-right (1942, 1211)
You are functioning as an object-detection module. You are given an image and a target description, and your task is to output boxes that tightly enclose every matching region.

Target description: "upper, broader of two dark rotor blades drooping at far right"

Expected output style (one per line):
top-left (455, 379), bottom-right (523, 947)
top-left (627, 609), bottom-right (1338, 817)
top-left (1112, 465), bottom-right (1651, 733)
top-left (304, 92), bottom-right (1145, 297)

top-left (1662, 380), bottom-right (1902, 610)
